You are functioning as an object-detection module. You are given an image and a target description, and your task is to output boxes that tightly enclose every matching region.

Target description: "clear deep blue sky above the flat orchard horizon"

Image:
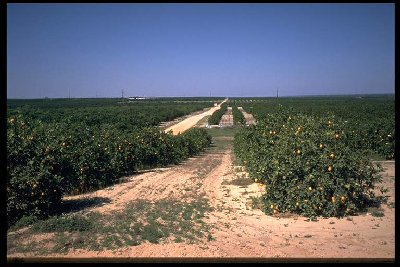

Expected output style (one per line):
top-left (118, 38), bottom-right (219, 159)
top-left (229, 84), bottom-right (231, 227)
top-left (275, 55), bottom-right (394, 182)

top-left (7, 3), bottom-right (395, 98)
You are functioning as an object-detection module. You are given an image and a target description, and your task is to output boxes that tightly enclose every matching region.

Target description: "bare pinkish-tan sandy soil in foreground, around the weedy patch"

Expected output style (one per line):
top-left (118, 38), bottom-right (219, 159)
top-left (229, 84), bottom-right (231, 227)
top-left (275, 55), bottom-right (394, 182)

top-left (8, 142), bottom-right (395, 260)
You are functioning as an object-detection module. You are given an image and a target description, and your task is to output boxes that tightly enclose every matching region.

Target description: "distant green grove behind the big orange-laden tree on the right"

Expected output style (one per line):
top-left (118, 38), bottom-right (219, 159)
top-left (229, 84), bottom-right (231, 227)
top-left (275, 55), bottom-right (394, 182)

top-left (236, 95), bottom-right (396, 159)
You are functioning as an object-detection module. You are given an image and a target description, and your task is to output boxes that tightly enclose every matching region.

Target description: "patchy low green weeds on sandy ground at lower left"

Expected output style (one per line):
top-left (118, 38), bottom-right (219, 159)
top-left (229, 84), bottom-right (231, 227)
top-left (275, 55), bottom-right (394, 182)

top-left (7, 198), bottom-right (214, 255)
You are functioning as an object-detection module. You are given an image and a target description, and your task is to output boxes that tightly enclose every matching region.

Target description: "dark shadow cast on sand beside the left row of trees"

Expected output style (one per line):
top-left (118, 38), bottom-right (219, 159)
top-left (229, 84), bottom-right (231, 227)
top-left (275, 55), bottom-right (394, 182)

top-left (59, 197), bottom-right (111, 216)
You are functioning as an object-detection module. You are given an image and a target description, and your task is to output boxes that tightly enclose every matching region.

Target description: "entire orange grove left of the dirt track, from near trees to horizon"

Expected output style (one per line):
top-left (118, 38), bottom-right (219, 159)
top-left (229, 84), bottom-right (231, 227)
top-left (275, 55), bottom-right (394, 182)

top-left (7, 99), bottom-right (225, 229)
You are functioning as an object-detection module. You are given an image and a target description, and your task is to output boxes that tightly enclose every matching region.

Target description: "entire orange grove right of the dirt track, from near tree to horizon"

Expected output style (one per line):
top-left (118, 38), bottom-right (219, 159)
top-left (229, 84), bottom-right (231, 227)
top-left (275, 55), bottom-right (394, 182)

top-left (235, 95), bottom-right (395, 219)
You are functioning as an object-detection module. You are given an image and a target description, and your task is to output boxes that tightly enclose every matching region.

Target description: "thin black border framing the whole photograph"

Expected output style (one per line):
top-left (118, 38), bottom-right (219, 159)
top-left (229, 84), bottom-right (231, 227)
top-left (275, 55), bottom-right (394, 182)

top-left (0, 1), bottom-right (400, 266)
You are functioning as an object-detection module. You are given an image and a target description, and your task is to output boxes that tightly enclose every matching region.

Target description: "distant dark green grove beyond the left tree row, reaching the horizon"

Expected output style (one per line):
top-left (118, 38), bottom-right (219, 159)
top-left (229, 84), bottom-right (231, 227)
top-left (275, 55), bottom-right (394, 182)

top-left (7, 99), bottom-right (219, 131)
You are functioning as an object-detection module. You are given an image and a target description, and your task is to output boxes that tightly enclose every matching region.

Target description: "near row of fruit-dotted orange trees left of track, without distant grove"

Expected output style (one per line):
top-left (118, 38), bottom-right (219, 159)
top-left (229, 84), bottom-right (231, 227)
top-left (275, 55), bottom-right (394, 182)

top-left (6, 100), bottom-right (216, 226)
